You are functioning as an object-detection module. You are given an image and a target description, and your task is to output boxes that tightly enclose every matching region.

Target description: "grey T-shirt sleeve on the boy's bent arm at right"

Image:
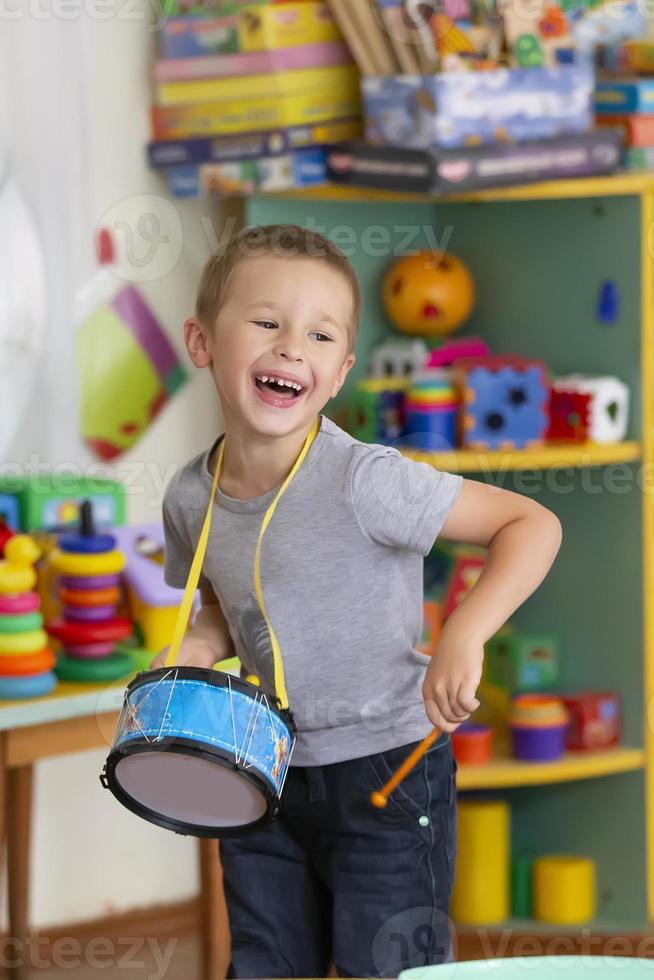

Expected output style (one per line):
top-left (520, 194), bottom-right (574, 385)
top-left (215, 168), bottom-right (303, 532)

top-left (351, 446), bottom-right (463, 555)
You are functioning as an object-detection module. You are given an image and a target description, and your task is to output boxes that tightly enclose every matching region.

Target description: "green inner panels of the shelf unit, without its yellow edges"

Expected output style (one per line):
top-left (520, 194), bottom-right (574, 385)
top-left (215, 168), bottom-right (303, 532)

top-left (248, 197), bottom-right (646, 923)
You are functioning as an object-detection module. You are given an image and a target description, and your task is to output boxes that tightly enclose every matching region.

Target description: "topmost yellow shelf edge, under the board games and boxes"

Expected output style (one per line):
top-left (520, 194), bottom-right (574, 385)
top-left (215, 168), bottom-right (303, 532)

top-left (272, 173), bottom-right (654, 204)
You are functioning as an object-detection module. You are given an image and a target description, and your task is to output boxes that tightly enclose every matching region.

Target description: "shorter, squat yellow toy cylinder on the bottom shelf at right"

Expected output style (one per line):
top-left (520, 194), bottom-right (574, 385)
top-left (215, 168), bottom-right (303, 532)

top-left (533, 854), bottom-right (596, 926)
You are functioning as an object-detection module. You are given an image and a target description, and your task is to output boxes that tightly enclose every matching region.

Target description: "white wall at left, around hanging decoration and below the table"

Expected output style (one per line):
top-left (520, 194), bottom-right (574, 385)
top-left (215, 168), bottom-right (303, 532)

top-left (0, 0), bottom-right (238, 928)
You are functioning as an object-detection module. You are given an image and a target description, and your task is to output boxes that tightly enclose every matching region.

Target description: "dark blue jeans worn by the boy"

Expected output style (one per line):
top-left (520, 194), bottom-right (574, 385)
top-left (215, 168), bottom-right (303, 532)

top-left (220, 736), bottom-right (456, 977)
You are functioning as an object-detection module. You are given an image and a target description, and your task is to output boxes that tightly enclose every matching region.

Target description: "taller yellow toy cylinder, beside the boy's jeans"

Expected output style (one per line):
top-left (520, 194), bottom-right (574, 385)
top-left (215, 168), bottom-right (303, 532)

top-left (452, 800), bottom-right (511, 926)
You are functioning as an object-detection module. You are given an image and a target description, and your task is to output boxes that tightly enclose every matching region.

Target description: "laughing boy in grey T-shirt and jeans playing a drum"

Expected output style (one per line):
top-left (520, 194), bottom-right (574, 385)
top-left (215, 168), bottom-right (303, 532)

top-left (155, 225), bottom-right (561, 977)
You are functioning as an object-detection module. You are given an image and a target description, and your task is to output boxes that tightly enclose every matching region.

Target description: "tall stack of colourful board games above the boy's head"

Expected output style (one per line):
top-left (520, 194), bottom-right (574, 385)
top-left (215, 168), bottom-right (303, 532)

top-left (148, 0), bottom-right (361, 196)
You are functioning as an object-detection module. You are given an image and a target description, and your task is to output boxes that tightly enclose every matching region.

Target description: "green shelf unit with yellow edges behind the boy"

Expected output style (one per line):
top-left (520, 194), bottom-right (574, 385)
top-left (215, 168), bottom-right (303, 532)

top-left (246, 174), bottom-right (654, 928)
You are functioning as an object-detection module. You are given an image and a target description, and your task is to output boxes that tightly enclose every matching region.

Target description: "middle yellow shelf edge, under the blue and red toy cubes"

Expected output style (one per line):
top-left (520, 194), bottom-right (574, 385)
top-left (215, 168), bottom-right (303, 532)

top-left (402, 441), bottom-right (641, 473)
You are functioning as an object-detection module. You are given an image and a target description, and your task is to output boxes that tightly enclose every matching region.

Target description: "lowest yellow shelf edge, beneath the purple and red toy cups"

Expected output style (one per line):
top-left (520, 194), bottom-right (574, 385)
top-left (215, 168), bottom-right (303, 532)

top-left (457, 747), bottom-right (646, 790)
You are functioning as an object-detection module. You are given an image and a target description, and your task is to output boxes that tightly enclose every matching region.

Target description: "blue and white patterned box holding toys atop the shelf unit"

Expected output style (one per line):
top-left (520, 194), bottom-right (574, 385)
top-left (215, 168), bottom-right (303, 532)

top-left (362, 64), bottom-right (594, 148)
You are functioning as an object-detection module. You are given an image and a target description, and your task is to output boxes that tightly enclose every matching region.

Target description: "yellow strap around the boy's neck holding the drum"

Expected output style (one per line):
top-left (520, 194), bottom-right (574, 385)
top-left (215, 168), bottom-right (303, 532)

top-left (165, 419), bottom-right (320, 709)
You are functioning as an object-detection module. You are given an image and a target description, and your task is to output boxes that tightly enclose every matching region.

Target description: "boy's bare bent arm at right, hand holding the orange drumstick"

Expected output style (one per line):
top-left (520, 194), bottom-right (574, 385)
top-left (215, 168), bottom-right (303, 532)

top-left (423, 480), bottom-right (561, 732)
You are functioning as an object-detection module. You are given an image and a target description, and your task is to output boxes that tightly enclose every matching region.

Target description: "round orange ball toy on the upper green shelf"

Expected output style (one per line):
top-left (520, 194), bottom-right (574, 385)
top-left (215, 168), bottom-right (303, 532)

top-left (382, 251), bottom-right (475, 337)
